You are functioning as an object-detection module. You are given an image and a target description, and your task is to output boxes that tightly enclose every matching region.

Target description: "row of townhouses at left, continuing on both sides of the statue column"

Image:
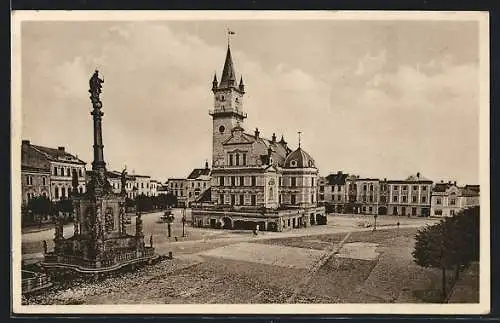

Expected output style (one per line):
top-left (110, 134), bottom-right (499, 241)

top-left (21, 140), bottom-right (165, 205)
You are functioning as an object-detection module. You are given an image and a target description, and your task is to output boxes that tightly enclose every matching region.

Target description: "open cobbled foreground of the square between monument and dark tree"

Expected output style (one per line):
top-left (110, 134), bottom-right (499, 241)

top-left (20, 216), bottom-right (446, 304)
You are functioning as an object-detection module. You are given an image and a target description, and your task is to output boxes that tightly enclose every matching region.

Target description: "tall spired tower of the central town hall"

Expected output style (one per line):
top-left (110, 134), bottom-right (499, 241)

top-left (210, 44), bottom-right (247, 167)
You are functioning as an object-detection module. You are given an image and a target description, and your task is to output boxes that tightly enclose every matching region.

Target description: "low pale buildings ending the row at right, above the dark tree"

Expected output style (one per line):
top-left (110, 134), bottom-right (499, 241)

top-left (431, 181), bottom-right (479, 217)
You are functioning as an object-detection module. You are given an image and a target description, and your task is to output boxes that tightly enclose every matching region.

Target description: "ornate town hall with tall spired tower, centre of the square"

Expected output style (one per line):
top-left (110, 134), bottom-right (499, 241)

top-left (192, 41), bottom-right (326, 231)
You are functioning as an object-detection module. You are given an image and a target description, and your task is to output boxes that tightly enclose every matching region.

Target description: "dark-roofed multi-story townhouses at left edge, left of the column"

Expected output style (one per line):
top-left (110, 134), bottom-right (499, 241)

top-left (21, 140), bottom-right (86, 203)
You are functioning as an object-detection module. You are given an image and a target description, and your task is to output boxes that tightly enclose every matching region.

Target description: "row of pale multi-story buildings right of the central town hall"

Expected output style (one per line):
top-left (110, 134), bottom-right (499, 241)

top-left (318, 172), bottom-right (479, 217)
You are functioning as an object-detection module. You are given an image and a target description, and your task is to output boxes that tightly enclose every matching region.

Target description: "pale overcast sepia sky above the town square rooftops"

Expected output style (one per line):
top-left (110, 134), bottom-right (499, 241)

top-left (21, 20), bottom-right (479, 184)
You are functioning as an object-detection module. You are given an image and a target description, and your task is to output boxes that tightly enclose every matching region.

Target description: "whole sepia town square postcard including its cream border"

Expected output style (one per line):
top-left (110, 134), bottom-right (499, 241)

top-left (10, 11), bottom-right (490, 314)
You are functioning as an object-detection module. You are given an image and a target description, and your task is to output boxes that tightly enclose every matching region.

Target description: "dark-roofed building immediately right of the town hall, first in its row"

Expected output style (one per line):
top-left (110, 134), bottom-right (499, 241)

top-left (318, 171), bottom-right (349, 213)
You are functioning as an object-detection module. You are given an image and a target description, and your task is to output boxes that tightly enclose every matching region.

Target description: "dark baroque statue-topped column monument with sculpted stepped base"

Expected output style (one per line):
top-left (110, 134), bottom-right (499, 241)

top-left (42, 71), bottom-right (157, 274)
